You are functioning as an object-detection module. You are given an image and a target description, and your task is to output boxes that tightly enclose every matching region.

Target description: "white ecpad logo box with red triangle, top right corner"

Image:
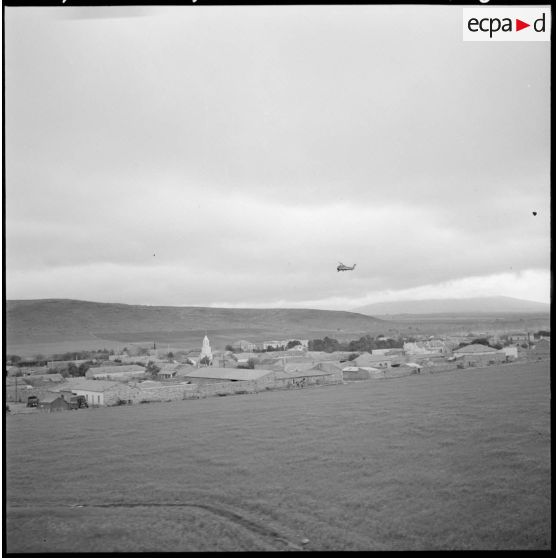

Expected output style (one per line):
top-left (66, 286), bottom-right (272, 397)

top-left (463, 7), bottom-right (552, 41)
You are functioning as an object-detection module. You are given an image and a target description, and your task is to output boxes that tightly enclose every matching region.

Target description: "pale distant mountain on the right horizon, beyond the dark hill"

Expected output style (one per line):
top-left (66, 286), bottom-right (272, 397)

top-left (352, 296), bottom-right (550, 316)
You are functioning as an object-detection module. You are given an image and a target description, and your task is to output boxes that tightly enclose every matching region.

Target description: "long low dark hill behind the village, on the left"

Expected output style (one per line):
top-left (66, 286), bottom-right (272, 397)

top-left (6, 299), bottom-right (385, 354)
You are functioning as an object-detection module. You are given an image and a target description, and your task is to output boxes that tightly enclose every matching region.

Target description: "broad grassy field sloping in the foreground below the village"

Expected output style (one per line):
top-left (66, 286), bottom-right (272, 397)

top-left (6, 361), bottom-right (552, 552)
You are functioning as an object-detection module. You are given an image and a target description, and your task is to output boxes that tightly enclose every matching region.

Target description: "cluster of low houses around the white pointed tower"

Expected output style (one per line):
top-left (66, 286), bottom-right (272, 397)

top-left (5, 335), bottom-right (550, 411)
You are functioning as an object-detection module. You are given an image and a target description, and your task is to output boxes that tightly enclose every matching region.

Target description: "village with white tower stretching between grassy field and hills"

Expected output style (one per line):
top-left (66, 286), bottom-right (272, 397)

top-left (5, 331), bottom-right (550, 414)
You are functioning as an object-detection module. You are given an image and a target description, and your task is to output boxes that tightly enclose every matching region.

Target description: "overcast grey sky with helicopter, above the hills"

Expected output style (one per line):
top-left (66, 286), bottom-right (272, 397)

top-left (4, 5), bottom-right (551, 309)
